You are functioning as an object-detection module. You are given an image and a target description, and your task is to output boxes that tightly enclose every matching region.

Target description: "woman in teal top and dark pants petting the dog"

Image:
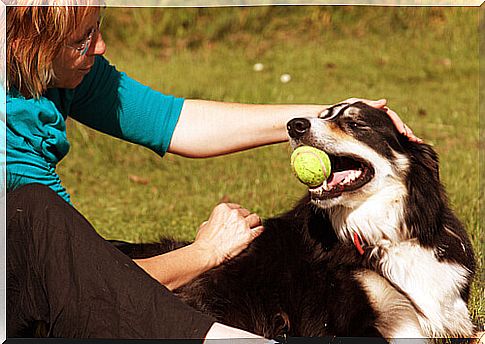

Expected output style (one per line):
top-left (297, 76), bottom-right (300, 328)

top-left (7, 1), bottom-right (417, 338)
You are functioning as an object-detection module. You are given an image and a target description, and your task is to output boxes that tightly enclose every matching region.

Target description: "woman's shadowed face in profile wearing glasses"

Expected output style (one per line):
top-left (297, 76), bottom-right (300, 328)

top-left (50, 9), bottom-right (106, 88)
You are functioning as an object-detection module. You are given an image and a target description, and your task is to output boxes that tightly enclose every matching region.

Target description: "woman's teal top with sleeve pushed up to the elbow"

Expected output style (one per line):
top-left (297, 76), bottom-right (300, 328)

top-left (6, 56), bottom-right (184, 202)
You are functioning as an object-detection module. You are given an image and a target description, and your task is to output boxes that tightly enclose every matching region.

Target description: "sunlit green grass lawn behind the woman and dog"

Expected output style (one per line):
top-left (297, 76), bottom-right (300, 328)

top-left (58, 7), bottom-right (485, 325)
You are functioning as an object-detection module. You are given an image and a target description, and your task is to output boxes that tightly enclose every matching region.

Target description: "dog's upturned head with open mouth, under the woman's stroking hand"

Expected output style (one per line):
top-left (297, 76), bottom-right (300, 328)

top-left (287, 102), bottom-right (440, 241)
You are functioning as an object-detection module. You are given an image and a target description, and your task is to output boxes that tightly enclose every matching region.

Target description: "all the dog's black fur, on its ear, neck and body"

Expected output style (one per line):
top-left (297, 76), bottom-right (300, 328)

top-left (112, 105), bottom-right (474, 338)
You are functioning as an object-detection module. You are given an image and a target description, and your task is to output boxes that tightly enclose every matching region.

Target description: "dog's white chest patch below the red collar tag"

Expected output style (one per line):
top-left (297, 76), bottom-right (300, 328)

top-left (375, 240), bottom-right (473, 337)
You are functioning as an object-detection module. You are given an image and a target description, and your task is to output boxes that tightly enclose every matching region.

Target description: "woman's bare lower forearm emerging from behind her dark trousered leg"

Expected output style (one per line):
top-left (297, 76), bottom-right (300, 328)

top-left (134, 244), bottom-right (217, 290)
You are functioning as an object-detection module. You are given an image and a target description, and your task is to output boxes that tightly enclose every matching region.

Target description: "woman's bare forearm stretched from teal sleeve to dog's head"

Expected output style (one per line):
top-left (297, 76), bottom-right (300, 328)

top-left (169, 100), bottom-right (327, 158)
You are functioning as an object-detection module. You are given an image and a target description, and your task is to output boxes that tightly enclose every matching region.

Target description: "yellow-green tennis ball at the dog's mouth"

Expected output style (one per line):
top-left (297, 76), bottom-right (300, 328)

top-left (291, 146), bottom-right (331, 187)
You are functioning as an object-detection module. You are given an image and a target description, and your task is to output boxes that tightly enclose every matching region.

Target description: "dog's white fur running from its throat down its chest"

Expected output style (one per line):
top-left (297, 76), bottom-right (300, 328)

top-left (330, 181), bottom-right (473, 337)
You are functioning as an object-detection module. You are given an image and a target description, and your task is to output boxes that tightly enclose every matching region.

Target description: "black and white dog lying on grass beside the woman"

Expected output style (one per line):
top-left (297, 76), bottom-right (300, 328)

top-left (119, 103), bottom-right (475, 338)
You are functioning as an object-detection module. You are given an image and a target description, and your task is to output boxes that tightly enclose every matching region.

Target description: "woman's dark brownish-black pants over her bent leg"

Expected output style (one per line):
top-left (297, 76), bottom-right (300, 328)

top-left (7, 184), bottom-right (214, 338)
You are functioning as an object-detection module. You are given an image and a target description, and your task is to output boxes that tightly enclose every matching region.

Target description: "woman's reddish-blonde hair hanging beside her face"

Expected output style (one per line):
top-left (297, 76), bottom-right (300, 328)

top-left (6, 0), bottom-right (99, 98)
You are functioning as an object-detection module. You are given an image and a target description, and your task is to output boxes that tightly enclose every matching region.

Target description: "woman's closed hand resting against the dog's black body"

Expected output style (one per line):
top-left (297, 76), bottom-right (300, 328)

top-left (192, 203), bottom-right (263, 266)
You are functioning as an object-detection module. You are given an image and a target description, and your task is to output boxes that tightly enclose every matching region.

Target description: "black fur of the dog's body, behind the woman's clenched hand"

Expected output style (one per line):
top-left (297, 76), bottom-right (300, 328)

top-left (113, 203), bottom-right (386, 338)
